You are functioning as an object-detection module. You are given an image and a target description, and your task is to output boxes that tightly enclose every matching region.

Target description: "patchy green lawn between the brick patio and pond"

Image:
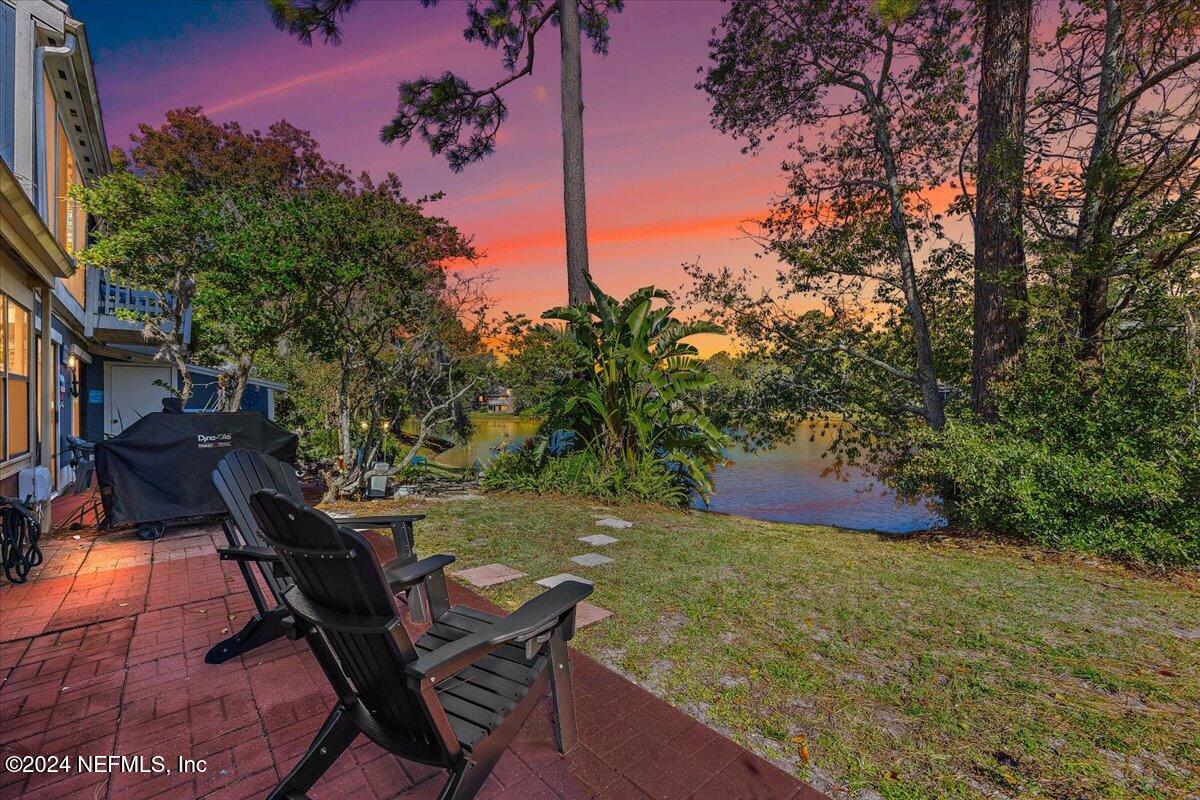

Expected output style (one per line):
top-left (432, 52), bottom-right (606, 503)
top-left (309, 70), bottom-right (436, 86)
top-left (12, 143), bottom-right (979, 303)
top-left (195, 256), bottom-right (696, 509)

top-left (328, 495), bottom-right (1200, 800)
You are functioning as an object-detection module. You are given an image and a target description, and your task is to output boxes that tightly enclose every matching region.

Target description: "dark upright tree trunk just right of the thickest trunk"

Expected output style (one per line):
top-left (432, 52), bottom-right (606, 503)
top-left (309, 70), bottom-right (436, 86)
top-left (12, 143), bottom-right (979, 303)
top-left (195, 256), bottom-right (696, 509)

top-left (1067, 0), bottom-right (1127, 362)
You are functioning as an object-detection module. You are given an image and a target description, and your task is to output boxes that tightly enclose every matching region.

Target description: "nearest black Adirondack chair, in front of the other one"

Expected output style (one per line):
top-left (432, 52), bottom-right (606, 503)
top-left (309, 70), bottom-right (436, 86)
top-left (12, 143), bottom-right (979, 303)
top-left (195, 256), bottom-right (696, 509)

top-left (239, 489), bottom-right (592, 800)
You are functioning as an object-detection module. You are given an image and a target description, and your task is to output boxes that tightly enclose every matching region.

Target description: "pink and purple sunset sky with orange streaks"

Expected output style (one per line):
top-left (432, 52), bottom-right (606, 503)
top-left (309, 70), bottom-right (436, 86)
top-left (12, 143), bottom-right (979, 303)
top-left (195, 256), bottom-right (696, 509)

top-left (84, 1), bottom-right (806, 349)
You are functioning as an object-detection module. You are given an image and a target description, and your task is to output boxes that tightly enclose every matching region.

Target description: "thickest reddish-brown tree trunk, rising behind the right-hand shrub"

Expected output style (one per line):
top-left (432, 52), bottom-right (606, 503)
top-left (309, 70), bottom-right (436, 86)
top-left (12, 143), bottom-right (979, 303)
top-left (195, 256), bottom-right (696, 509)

top-left (971, 0), bottom-right (1033, 422)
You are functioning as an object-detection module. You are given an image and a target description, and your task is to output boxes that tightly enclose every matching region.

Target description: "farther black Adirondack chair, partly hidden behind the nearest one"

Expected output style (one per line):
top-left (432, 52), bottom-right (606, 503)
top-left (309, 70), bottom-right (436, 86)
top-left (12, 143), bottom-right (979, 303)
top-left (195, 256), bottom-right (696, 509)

top-left (204, 450), bottom-right (427, 663)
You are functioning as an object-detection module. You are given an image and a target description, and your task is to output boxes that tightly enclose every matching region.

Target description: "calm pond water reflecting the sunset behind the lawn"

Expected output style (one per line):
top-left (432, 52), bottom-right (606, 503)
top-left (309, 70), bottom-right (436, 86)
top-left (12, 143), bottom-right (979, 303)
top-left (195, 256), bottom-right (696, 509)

top-left (437, 416), bottom-right (942, 533)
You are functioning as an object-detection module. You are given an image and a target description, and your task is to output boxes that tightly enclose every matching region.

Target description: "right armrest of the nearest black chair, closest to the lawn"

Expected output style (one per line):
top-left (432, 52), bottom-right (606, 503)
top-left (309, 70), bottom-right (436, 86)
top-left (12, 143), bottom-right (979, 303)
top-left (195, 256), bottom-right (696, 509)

top-left (408, 581), bottom-right (593, 685)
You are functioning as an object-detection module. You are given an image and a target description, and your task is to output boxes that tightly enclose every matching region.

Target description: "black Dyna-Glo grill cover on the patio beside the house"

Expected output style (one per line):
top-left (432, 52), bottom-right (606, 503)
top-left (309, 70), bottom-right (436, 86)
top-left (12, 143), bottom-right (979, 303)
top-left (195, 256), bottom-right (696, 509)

top-left (96, 411), bottom-right (299, 528)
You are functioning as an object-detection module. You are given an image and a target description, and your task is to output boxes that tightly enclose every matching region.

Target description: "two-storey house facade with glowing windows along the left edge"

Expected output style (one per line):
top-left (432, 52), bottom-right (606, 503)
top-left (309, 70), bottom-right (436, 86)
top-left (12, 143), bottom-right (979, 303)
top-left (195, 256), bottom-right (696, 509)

top-left (0, 0), bottom-right (108, 510)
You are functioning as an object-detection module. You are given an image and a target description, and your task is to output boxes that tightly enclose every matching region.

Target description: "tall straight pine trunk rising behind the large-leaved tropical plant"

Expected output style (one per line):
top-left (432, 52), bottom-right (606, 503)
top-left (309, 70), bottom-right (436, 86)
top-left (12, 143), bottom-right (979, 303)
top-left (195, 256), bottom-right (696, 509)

top-left (559, 0), bottom-right (590, 306)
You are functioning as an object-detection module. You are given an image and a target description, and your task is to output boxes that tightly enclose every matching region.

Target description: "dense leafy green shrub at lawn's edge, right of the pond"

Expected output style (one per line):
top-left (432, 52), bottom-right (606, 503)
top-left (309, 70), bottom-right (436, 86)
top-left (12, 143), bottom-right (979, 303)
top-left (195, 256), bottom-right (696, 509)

top-left (894, 351), bottom-right (1200, 565)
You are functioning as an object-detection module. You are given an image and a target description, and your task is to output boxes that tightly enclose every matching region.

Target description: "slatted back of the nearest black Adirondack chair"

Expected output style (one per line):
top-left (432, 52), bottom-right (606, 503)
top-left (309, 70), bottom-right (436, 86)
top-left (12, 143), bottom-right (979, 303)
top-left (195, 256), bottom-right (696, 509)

top-left (250, 489), bottom-right (457, 754)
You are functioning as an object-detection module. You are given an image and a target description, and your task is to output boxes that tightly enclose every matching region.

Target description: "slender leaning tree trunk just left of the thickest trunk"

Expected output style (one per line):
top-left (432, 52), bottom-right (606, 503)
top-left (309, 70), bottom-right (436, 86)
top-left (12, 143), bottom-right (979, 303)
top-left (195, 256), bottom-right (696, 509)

top-left (871, 108), bottom-right (946, 431)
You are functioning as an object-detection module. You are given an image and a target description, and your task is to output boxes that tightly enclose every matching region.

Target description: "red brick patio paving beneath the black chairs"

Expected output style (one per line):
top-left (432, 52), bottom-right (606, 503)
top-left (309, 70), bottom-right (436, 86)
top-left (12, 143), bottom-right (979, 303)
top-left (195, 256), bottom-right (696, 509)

top-left (0, 513), bottom-right (824, 800)
